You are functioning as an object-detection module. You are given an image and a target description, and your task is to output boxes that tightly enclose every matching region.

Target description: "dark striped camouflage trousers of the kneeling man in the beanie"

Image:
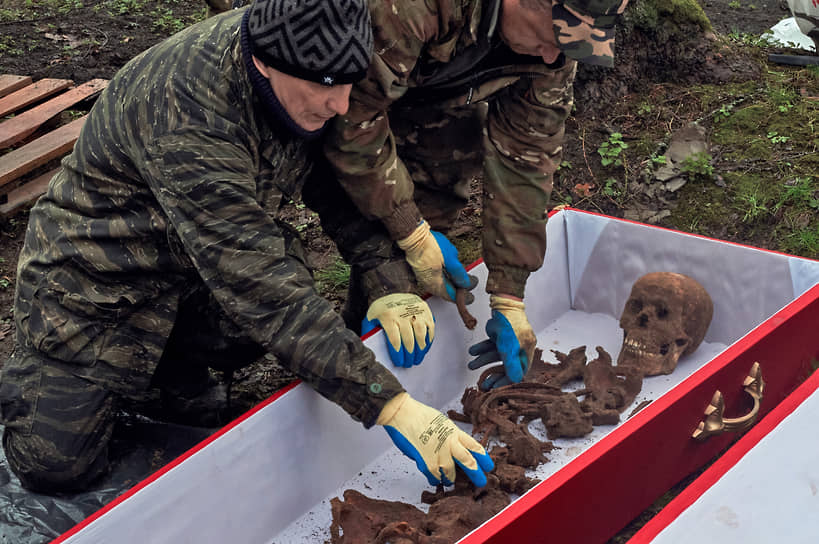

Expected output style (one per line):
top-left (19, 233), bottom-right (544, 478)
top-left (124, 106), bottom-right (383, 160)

top-left (0, 230), bottom-right (304, 494)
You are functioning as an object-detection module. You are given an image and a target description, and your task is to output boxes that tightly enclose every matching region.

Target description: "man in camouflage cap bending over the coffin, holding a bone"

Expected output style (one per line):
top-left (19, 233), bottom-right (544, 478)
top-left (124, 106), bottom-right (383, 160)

top-left (325, 0), bottom-right (627, 388)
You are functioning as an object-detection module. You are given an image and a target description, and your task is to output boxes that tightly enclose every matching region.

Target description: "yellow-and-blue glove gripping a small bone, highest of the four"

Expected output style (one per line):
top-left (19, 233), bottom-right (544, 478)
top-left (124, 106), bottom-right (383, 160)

top-left (396, 221), bottom-right (478, 304)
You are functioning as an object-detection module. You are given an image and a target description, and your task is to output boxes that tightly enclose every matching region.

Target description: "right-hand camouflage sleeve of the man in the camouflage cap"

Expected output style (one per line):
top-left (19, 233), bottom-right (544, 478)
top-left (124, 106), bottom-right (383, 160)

top-left (483, 59), bottom-right (576, 297)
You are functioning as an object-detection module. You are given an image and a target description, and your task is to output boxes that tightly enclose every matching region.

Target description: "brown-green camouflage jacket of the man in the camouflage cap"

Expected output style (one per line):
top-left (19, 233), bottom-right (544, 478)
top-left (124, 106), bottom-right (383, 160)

top-left (325, 0), bottom-right (576, 297)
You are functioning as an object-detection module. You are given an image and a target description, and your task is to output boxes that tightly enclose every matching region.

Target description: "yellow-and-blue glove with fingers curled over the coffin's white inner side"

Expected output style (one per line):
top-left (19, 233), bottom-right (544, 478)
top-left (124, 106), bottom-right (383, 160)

top-left (361, 293), bottom-right (435, 368)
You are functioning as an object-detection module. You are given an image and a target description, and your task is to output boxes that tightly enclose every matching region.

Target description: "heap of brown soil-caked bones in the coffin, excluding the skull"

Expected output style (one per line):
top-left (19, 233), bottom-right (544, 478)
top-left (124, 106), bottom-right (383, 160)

top-left (330, 346), bottom-right (642, 544)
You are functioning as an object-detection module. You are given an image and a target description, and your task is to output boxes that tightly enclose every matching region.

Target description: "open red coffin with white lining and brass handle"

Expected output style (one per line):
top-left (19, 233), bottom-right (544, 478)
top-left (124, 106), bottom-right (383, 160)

top-left (54, 210), bottom-right (819, 544)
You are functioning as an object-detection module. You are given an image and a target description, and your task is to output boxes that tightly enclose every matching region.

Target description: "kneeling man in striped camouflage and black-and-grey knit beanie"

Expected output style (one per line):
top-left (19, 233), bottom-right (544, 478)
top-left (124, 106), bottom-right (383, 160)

top-left (0, 0), bottom-right (489, 493)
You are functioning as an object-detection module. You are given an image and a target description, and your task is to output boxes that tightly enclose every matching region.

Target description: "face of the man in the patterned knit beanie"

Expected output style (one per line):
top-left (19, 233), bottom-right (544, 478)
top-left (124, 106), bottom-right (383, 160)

top-left (253, 57), bottom-right (353, 132)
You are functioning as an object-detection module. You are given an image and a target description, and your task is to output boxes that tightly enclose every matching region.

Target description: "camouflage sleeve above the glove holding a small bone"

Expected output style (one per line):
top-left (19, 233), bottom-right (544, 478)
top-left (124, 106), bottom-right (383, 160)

top-left (325, 0), bottom-right (446, 239)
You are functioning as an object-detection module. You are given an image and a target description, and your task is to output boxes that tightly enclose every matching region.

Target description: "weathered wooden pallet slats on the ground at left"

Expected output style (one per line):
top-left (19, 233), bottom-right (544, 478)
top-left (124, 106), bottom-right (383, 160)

top-left (0, 74), bottom-right (108, 216)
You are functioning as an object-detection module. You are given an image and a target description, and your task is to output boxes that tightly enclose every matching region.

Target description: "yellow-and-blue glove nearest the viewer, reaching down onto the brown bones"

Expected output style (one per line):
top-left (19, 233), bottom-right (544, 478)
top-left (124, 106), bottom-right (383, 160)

top-left (376, 392), bottom-right (495, 487)
